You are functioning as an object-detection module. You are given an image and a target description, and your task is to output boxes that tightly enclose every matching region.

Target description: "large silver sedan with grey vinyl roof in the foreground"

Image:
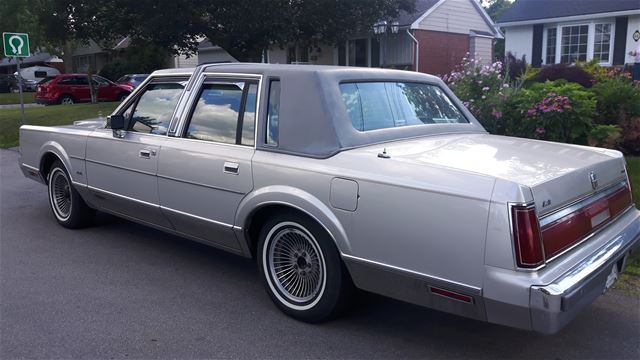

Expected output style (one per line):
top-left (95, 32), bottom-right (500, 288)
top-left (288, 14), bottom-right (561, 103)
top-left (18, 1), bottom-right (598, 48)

top-left (20, 63), bottom-right (640, 333)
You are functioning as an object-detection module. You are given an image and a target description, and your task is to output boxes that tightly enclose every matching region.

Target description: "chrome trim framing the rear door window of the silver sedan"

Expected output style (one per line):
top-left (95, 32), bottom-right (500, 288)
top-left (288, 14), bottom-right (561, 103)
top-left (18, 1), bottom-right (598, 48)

top-left (172, 72), bottom-right (264, 149)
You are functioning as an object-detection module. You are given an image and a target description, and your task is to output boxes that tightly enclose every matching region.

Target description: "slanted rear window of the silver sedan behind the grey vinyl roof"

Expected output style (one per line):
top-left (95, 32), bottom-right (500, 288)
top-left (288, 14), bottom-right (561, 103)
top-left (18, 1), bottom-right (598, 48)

top-left (340, 82), bottom-right (469, 131)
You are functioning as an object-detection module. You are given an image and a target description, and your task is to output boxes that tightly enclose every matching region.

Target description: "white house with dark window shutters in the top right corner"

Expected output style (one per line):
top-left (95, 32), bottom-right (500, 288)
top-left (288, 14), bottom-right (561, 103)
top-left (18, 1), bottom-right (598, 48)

top-left (497, 0), bottom-right (640, 67)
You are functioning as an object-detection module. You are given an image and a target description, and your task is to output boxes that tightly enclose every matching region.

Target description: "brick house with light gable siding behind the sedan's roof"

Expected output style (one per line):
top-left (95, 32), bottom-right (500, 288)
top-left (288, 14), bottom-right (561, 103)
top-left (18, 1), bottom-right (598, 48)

top-left (198, 0), bottom-right (502, 74)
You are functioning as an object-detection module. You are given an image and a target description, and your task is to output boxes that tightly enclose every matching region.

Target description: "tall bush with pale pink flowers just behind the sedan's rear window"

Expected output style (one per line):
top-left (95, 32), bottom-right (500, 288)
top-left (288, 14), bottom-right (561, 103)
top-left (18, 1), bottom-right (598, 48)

top-left (443, 54), bottom-right (511, 134)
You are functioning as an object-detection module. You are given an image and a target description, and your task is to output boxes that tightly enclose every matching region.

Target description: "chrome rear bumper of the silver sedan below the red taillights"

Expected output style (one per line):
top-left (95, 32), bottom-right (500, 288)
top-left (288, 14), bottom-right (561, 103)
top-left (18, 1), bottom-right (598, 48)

top-left (530, 211), bottom-right (640, 334)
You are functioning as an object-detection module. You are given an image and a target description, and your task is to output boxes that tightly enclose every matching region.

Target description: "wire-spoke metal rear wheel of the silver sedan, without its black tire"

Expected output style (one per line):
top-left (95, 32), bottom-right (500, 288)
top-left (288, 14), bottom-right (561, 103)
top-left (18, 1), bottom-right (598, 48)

top-left (267, 225), bottom-right (326, 304)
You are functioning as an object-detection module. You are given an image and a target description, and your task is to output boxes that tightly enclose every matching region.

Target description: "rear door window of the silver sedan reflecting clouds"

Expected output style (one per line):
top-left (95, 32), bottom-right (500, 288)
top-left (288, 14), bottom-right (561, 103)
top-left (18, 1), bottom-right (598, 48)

top-left (185, 82), bottom-right (258, 146)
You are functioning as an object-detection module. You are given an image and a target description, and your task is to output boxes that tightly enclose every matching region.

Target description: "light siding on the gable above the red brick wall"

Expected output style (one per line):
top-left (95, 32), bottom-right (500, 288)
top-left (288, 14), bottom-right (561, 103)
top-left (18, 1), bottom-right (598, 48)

top-left (418, 0), bottom-right (494, 34)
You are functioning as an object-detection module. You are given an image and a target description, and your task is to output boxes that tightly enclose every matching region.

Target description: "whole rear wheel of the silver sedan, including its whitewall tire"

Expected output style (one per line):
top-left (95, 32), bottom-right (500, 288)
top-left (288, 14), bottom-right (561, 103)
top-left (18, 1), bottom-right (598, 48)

top-left (257, 212), bottom-right (353, 323)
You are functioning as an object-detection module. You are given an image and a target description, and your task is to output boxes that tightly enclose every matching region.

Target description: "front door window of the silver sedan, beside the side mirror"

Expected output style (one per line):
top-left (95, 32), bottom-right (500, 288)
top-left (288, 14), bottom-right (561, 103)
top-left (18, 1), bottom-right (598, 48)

top-left (124, 82), bottom-right (185, 135)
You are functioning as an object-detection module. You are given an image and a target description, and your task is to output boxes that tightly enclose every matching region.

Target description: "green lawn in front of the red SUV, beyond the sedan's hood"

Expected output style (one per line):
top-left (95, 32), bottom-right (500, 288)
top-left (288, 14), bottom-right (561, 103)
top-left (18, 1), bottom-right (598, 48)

top-left (0, 102), bottom-right (120, 148)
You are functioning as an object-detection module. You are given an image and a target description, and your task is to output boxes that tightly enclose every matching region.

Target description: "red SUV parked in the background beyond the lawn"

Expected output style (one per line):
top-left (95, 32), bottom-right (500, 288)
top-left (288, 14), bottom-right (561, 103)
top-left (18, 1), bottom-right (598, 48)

top-left (36, 74), bottom-right (133, 105)
